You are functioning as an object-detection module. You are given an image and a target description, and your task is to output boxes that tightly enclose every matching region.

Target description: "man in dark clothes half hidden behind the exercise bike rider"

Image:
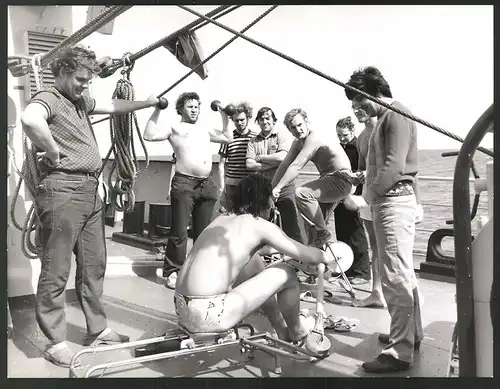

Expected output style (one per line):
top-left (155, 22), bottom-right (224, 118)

top-left (334, 117), bottom-right (371, 285)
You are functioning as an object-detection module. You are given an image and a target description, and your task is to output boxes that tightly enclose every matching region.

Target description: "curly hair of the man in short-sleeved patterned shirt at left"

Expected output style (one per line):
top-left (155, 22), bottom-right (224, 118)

top-left (50, 45), bottom-right (101, 77)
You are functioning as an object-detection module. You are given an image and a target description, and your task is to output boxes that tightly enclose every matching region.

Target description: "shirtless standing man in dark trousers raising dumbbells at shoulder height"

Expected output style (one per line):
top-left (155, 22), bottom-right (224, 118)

top-left (143, 92), bottom-right (233, 289)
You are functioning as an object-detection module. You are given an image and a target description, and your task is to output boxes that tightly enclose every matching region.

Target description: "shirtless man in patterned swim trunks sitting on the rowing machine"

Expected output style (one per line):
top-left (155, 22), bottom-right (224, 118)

top-left (174, 173), bottom-right (331, 342)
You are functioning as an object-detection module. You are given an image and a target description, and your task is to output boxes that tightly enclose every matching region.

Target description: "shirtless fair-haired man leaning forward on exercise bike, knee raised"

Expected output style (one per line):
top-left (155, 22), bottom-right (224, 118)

top-left (272, 108), bottom-right (352, 248)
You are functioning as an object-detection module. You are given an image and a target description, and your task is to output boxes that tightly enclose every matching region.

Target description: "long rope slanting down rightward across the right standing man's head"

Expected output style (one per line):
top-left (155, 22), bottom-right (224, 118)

top-left (178, 5), bottom-right (494, 157)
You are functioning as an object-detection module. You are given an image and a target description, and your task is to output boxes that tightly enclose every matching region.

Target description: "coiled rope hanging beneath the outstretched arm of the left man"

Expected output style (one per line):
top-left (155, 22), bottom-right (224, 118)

top-left (105, 53), bottom-right (149, 212)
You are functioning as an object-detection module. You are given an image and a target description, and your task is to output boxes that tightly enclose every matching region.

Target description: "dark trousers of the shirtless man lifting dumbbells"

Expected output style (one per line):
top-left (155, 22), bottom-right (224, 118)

top-left (163, 173), bottom-right (217, 276)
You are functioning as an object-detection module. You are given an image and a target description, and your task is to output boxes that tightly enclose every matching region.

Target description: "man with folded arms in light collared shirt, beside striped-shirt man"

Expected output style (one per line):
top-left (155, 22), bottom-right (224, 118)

top-left (247, 107), bottom-right (303, 243)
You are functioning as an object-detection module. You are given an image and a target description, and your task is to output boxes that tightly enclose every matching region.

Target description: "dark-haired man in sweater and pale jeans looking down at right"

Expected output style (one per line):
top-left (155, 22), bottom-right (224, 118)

top-left (345, 67), bottom-right (424, 373)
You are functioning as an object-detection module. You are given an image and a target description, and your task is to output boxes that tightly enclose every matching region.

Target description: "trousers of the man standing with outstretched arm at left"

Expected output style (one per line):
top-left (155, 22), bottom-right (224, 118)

top-left (35, 173), bottom-right (107, 343)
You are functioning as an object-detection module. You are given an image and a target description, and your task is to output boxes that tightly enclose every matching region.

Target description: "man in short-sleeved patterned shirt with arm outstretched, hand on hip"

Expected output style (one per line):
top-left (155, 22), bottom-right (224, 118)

top-left (21, 46), bottom-right (158, 367)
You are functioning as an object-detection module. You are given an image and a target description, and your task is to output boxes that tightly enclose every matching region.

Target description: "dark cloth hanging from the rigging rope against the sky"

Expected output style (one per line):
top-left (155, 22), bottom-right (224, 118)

top-left (163, 31), bottom-right (208, 80)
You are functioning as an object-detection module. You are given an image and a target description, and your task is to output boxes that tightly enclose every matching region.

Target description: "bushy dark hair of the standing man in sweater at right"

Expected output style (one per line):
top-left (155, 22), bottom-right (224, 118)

top-left (344, 66), bottom-right (392, 101)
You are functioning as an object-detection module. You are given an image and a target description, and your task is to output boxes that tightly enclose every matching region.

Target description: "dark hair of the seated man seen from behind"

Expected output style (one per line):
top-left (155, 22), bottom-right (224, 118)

top-left (228, 173), bottom-right (272, 217)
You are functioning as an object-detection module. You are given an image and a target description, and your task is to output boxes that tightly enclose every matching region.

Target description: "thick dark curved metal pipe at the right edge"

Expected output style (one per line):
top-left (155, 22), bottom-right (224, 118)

top-left (453, 104), bottom-right (494, 377)
